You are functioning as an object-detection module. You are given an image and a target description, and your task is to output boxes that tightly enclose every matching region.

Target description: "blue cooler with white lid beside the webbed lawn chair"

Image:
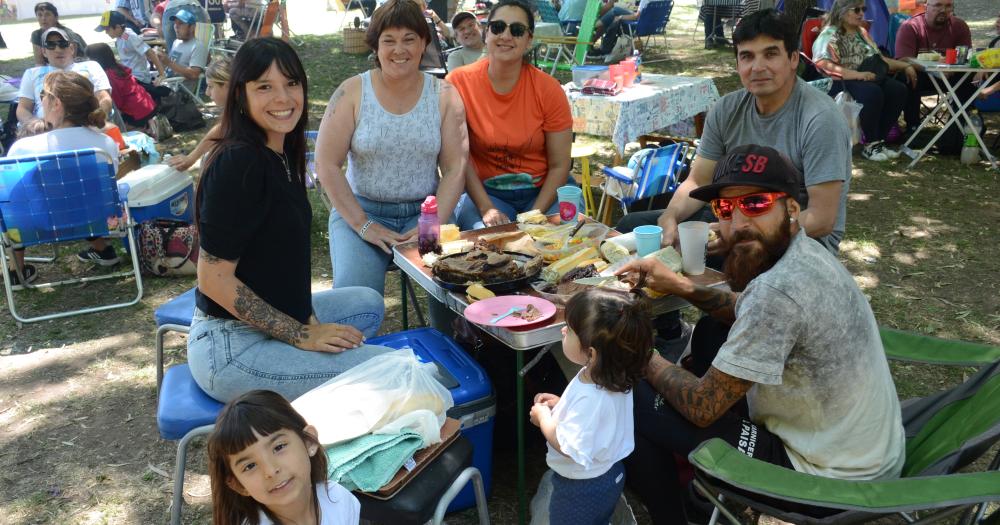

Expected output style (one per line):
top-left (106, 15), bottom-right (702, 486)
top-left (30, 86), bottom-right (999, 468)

top-left (118, 164), bottom-right (194, 223)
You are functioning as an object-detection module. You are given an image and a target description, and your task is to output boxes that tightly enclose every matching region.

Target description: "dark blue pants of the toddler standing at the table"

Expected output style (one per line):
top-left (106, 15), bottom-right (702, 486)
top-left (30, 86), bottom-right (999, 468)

top-left (549, 461), bottom-right (625, 525)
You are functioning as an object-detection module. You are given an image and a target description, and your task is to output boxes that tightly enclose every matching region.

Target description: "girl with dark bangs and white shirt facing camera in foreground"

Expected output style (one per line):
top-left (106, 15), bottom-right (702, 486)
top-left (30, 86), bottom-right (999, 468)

top-left (208, 390), bottom-right (361, 525)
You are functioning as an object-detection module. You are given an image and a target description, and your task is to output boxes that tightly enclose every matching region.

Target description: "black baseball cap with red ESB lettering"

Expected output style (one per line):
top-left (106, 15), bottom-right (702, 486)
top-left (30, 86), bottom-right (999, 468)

top-left (691, 144), bottom-right (805, 205)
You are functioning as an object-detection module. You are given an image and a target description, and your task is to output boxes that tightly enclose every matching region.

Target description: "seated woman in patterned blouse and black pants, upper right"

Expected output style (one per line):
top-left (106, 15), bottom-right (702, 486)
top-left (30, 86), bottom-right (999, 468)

top-left (813, 0), bottom-right (917, 161)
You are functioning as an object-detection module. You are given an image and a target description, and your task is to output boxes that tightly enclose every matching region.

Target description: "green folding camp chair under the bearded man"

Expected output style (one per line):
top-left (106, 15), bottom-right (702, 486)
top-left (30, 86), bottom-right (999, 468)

top-left (688, 328), bottom-right (1000, 524)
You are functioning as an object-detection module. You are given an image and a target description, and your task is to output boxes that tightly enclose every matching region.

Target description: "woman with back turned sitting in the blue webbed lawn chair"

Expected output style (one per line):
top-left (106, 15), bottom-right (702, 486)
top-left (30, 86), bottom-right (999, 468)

top-left (7, 71), bottom-right (119, 284)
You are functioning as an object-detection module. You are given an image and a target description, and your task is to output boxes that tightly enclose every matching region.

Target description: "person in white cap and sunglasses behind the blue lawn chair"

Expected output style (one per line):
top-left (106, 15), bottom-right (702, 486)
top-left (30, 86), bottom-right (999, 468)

top-left (17, 27), bottom-right (112, 124)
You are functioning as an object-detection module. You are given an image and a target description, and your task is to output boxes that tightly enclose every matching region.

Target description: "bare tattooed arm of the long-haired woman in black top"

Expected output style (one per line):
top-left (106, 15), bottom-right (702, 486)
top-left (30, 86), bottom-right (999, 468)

top-left (198, 249), bottom-right (363, 352)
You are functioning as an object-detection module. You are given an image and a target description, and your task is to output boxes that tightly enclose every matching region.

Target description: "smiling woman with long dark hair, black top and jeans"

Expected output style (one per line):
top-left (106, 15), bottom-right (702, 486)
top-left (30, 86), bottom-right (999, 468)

top-left (188, 38), bottom-right (389, 401)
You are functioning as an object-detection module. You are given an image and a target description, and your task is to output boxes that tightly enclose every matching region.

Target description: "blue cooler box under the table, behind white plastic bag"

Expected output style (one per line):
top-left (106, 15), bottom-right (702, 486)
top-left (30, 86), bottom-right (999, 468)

top-left (366, 328), bottom-right (497, 512)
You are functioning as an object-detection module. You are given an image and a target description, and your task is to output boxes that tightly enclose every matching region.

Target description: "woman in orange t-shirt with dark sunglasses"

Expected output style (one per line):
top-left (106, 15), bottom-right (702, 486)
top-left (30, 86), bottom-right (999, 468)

top-left (448, 0), bottom-right (573, 230)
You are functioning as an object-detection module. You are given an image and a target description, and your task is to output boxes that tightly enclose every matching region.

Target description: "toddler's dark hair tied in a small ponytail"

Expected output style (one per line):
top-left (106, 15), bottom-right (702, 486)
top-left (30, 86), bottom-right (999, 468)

top-left (566, 287), bottom-right (653, 392)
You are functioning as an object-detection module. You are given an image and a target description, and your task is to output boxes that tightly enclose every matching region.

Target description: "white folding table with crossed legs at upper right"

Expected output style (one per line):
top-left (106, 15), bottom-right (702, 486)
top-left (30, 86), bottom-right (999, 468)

top-left (902, 60), bottom-right (1000, 169)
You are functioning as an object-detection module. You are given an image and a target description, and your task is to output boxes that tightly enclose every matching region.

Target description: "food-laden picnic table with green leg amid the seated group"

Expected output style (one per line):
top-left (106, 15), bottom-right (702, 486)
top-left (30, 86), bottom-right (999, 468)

top-left (392, 215), bottom-right (726, 525)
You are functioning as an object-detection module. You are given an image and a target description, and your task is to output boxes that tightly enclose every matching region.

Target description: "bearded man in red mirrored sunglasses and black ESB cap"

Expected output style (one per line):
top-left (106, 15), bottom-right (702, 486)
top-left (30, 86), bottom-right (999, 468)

top-left (619, 145), bottom-right (905, 523)
